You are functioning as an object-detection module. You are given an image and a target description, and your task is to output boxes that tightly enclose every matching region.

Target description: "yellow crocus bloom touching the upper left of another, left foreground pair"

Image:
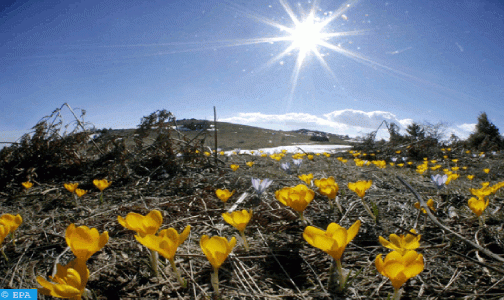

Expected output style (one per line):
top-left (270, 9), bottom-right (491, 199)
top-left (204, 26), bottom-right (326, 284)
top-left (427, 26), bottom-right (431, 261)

top-left (117, 209), bottom-right (163, 237)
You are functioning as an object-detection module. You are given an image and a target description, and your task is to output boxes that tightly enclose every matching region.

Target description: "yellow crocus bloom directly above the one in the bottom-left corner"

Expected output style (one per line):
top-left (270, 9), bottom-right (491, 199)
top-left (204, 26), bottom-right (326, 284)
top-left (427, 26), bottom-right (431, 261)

top-left (65, 223), bottom-right (109, 261)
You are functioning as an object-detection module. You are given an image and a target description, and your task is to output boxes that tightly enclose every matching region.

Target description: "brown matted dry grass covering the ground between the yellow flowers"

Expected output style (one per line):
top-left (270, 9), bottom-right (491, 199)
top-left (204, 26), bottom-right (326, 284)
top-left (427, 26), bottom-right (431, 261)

top-left (0, 122), bottom-right (504, 299)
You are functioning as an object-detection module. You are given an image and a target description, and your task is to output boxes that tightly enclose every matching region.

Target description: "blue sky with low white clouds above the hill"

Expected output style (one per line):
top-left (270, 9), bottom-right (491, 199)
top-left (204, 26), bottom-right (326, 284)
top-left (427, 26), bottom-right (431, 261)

top-left (0, 0), bottom-right (504, 141)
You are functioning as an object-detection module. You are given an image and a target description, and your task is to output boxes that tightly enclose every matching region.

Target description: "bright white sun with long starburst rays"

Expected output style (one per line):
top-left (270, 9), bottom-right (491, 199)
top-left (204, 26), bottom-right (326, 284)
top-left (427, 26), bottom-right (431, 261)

top-left (100, 0), bottom-right (475, 102)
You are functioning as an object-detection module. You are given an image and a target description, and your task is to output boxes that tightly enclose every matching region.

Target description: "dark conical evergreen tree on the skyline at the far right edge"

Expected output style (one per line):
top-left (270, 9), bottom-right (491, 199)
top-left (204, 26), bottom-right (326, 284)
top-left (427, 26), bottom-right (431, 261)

top-left (467, 112), bottom-right (503, 151)
